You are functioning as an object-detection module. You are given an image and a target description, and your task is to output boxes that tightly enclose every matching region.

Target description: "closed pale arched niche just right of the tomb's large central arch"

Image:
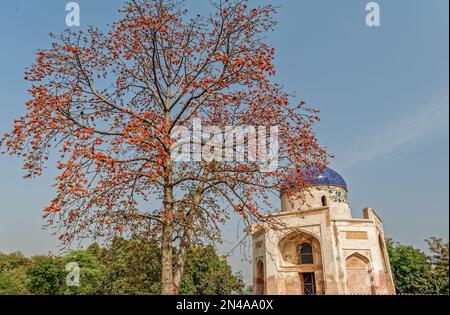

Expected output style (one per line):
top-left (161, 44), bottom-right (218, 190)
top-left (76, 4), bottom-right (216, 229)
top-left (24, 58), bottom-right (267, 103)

top-left (345, 253), bottom-right (374, 295)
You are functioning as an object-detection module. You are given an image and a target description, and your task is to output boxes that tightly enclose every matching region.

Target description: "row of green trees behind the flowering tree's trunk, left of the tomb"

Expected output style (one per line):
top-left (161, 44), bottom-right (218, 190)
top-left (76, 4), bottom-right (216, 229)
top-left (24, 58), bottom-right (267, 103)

top-left (0, 237), bottom-right (244, 295)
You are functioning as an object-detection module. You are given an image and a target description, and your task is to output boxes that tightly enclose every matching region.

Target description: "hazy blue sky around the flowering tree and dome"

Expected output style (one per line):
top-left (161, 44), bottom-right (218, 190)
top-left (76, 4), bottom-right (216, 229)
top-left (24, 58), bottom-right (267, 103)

top-left (0, 0), bottom-right (449, 282)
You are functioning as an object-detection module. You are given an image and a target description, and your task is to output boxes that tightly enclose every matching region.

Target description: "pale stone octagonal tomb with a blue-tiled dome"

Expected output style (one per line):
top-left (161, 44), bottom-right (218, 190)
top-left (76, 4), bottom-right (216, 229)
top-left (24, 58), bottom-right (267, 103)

top-left (250, 168), bottom-right (395, 295)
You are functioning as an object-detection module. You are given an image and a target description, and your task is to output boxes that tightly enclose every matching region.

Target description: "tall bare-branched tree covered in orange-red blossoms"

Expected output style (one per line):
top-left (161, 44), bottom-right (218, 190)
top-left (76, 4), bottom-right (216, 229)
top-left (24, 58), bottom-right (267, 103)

top-left (1, 0), bottom-right (328, 294)
